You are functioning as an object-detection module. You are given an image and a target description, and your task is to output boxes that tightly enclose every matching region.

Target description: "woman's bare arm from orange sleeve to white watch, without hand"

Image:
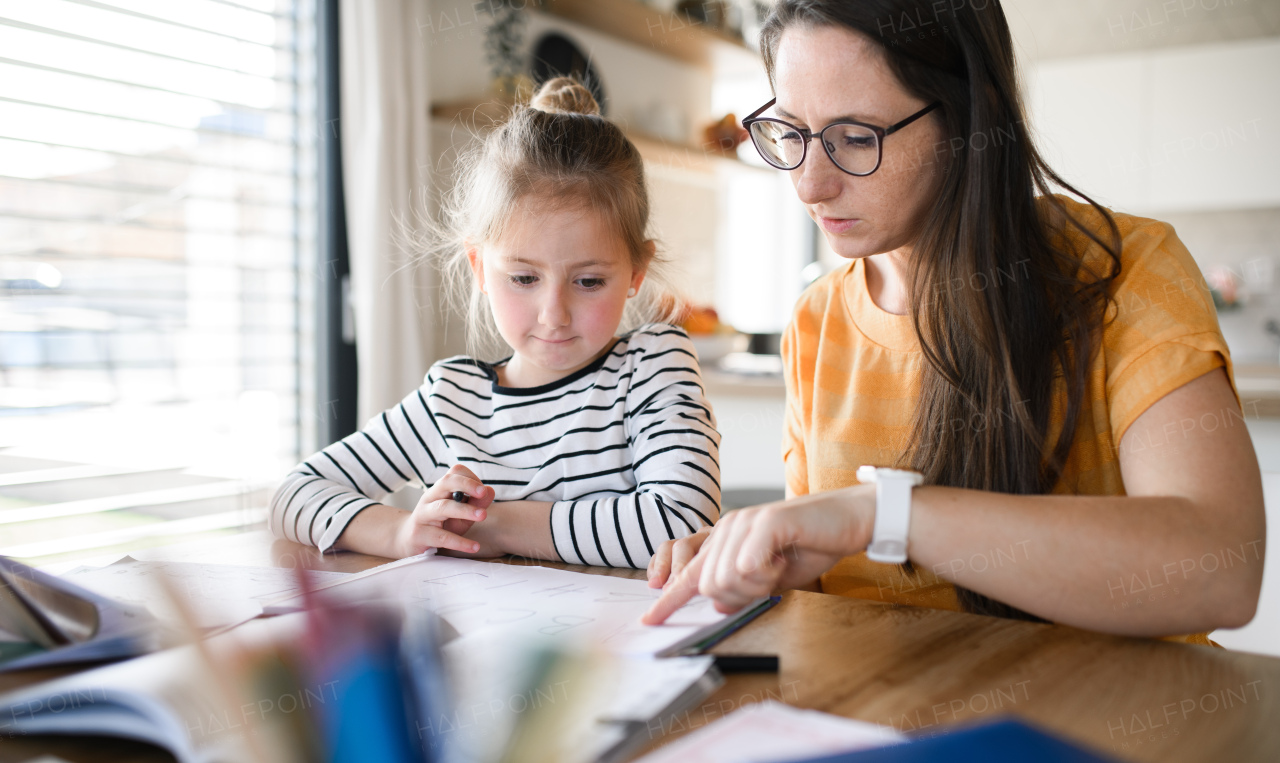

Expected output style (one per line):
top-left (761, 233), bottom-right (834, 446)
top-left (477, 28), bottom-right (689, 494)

top-left (910, 370), bottom-right (1266, 636)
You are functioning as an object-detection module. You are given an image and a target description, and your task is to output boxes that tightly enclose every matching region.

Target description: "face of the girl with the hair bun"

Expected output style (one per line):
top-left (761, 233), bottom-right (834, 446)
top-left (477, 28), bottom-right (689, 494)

top-left (467, 204), bottom-right (652, 387)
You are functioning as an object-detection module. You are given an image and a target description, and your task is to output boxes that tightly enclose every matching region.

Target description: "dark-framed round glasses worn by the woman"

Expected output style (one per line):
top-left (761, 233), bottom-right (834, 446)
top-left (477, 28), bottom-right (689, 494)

top-left (742, 99), bottom-right (942, 177)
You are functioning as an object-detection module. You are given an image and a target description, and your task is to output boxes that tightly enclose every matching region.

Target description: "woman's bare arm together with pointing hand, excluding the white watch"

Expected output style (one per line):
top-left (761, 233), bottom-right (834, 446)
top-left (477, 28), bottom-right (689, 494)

top-left (648, 370), bottom-right (1266, 636)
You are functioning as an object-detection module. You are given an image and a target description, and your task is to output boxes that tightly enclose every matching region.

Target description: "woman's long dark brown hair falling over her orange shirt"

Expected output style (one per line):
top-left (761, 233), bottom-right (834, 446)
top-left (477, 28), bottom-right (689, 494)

top-left (760, 0), bottom-right (1120, 620)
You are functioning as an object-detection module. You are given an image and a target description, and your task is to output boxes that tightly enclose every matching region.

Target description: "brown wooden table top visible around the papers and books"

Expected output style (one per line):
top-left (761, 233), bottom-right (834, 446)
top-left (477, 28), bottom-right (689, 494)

top-left (0, 533), bottom-right (1280, 763)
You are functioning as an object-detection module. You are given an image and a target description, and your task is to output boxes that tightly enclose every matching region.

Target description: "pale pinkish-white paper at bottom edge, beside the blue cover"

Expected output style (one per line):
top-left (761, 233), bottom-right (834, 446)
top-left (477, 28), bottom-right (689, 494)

top-left (636, 702), bottom-right (906, 763)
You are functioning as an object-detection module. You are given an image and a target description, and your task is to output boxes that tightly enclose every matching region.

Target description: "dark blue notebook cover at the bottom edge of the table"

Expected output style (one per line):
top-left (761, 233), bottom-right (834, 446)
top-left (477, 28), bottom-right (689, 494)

top-left (788, 721), bottom-right (1116, 763)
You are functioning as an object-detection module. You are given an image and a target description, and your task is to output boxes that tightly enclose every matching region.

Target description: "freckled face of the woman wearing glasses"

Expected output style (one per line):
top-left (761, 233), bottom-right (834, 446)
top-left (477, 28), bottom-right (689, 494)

top-left (773, 26), bottom-right (946, 259)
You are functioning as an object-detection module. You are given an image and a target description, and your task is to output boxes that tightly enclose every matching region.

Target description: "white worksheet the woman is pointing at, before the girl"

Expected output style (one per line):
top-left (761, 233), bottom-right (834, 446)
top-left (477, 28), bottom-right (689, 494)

top-left (256, 557), bottom-right (762, 657)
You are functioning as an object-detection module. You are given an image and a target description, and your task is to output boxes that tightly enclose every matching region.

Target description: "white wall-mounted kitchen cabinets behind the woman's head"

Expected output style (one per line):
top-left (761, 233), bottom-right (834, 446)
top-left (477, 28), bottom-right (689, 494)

top-left (1027, 40), bottom-right (1280, 214)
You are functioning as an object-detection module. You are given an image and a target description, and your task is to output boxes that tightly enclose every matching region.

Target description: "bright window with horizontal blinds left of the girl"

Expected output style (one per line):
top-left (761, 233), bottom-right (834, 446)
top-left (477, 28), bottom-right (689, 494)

top-left (0, 0), bottom-right (317, 565)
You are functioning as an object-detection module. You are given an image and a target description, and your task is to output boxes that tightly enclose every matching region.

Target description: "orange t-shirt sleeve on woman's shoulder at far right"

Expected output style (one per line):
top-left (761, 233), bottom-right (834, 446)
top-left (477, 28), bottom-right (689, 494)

top-left (1103, 221), bottom-right (1239, 444)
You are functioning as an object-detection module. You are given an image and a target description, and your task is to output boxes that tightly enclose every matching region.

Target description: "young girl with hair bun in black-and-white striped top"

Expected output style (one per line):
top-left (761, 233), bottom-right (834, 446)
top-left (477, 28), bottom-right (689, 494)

top-left (269, 78), bottom-right (721, 568)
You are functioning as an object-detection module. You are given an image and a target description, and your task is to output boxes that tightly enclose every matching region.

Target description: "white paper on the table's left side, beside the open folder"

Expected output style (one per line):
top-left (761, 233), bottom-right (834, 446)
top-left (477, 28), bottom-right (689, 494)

top-left (63, 557), bottom-right (349, 629)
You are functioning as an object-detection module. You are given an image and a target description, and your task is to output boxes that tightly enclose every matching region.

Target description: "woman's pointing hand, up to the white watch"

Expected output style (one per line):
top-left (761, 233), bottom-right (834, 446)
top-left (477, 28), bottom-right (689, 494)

top-left (641, 485), bottom-right (876, 625)
